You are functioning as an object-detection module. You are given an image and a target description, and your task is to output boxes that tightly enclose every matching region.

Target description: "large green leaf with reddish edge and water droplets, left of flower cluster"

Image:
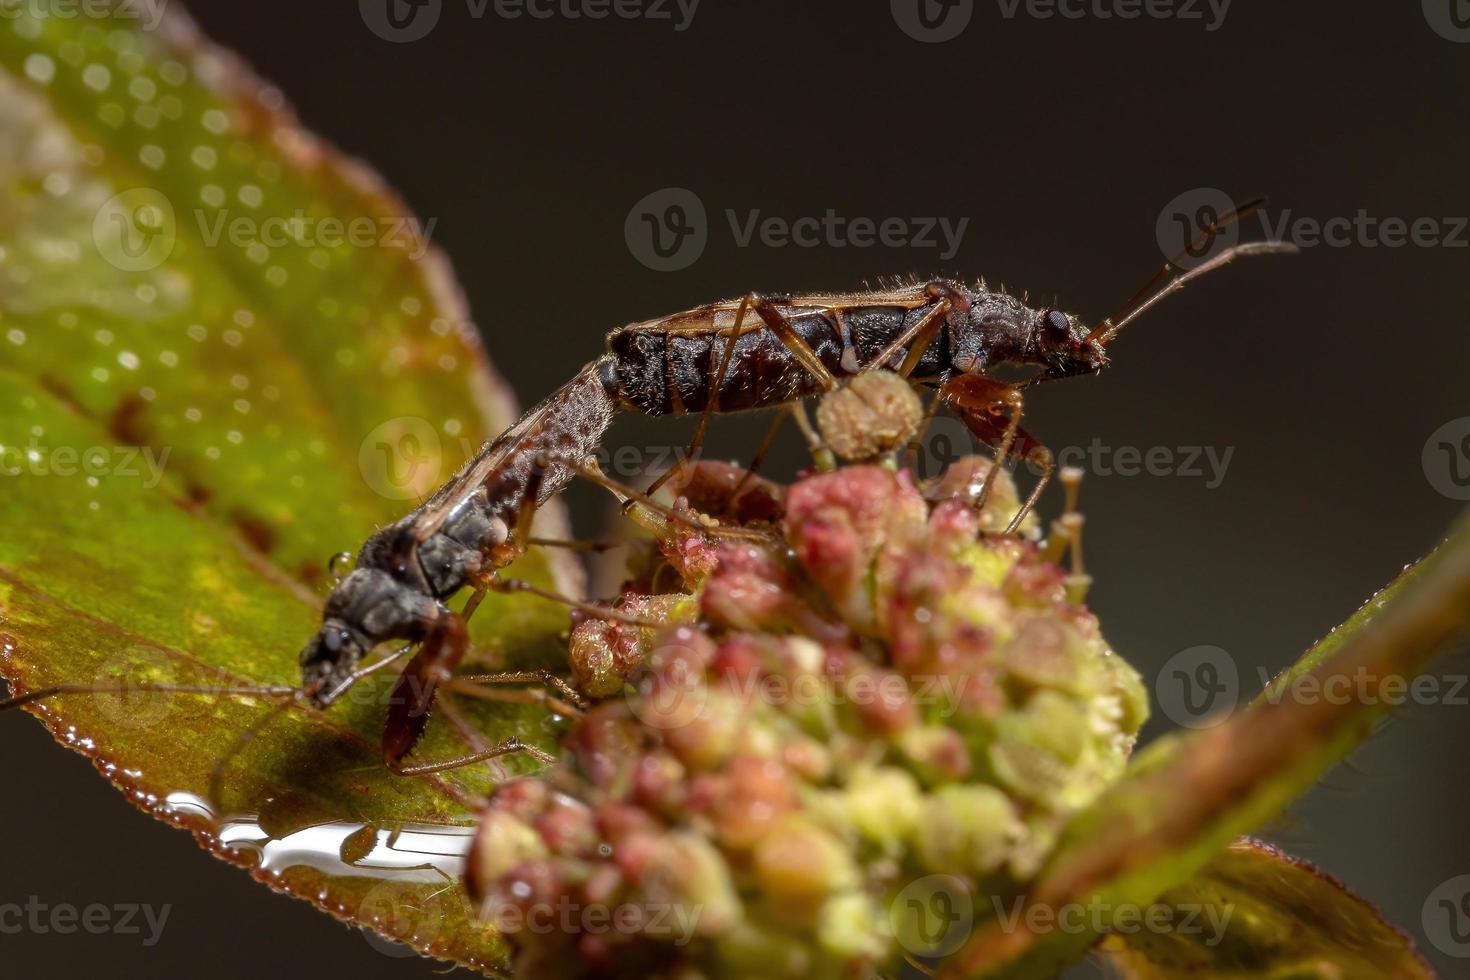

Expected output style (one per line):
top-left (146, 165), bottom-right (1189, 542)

top-left (0, 4), bottom-right (566, 970)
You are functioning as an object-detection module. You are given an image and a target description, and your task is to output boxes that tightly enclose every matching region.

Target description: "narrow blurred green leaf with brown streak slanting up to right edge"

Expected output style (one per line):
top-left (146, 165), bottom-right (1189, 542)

top-left (942, 519), bottom-right (1470, 977)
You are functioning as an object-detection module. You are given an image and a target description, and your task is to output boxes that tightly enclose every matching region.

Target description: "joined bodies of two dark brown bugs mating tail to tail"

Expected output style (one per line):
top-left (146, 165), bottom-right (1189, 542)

top-left (301, 281), bottom-right (1101, 699)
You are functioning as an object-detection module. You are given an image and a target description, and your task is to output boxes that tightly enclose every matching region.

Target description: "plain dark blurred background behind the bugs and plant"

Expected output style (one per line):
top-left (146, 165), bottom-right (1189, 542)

top-left (0, 0), bottom-right (1470, 977)
